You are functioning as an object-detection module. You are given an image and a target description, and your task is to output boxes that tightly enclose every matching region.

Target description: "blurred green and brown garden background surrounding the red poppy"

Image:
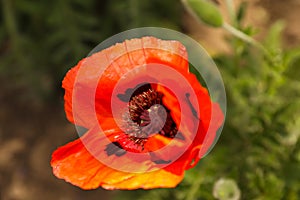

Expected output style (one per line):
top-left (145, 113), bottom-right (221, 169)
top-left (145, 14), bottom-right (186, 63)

top-left (0, 0), bottom-right (300, 200)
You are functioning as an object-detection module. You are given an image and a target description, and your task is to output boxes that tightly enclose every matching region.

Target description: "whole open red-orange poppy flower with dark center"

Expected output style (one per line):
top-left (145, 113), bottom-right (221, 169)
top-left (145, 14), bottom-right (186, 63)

top-left (51, 37), bottom-right (224, 189)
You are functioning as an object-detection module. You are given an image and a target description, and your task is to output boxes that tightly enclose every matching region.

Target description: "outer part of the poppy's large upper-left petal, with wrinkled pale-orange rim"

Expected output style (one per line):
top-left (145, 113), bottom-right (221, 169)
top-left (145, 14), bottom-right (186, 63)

top-left (63, 37), bottom-right (188, 128)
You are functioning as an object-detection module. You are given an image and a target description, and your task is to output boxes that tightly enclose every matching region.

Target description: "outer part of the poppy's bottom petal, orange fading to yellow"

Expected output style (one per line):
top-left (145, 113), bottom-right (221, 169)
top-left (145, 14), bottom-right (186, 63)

top-left (51, 126), bottom-right (183, 189)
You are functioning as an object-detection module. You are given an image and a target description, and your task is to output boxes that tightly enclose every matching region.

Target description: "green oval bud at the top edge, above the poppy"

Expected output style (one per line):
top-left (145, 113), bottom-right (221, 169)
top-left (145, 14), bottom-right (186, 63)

top-left (186, 0), bottom-right (223, 27)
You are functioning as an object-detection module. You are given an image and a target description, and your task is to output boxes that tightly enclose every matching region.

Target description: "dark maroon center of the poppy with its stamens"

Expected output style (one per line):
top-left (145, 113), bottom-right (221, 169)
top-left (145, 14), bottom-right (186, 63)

top-left (123, 88), bottom-right (177, 146)
